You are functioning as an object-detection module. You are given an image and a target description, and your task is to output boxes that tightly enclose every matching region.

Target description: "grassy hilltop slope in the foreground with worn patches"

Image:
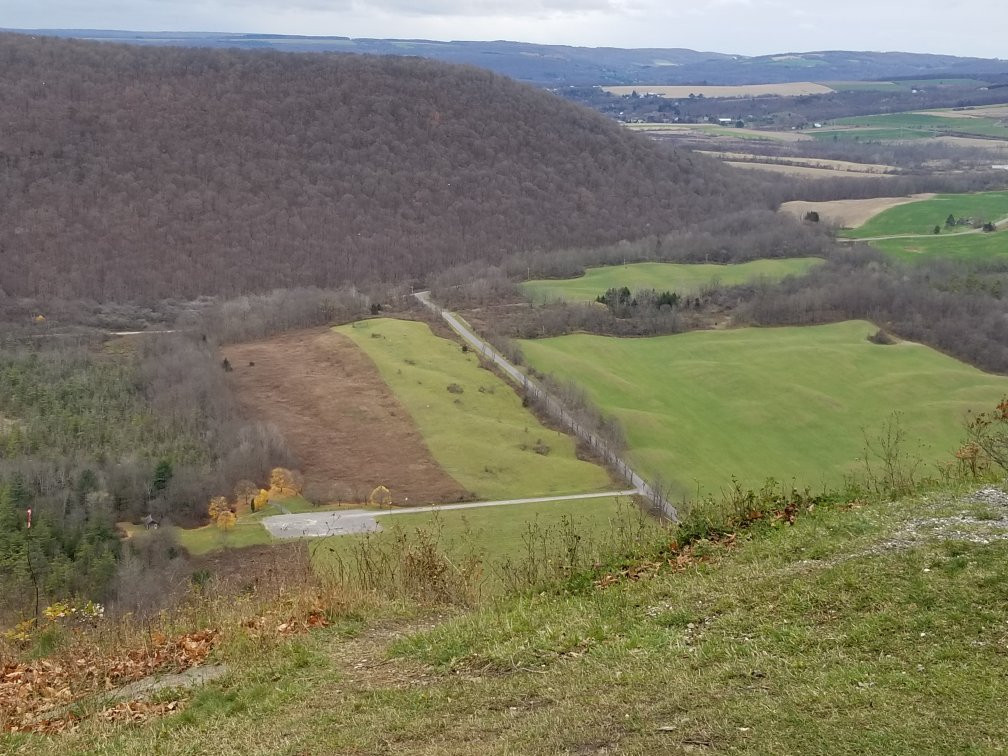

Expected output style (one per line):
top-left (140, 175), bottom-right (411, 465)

top-left (17, 481), bottom-right (1008, 755)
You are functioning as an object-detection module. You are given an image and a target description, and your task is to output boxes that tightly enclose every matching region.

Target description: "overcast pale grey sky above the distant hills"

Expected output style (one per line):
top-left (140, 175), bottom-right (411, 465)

top-left (7, 0), bottom-right (1008, 57)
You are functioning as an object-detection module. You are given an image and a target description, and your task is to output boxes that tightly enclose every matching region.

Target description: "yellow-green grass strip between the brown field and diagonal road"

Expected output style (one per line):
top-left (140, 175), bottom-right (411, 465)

top-left (334, 319), bottom-right (622, 499)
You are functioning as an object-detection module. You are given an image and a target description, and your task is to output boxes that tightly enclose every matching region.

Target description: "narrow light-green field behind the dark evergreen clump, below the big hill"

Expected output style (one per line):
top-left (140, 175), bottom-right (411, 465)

top-left (522, 257), bottom-right (823, 302)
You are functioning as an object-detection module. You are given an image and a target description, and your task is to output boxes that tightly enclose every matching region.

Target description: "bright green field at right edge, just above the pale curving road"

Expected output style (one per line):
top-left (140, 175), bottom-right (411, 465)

top-left (844, 192), bottom-right (1008, 239)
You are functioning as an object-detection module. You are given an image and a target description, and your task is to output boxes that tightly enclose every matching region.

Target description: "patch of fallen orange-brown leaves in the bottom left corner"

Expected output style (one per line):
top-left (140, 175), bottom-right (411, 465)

top-left (0, 630), bottom-right (220, 733)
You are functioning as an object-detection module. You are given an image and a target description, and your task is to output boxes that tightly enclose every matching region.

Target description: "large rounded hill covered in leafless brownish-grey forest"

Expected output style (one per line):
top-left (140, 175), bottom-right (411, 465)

top-left (0, 34), bottom-right (760, 301)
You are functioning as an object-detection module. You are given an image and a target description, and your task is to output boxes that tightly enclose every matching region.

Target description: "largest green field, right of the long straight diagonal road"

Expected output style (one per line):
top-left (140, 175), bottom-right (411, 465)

top-left (521, 322), bottom-right (1008, 496)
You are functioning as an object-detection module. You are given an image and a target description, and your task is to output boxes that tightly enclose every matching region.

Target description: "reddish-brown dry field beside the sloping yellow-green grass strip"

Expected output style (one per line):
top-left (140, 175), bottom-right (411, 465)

top-left (221, 329), bottom-right (472, 505)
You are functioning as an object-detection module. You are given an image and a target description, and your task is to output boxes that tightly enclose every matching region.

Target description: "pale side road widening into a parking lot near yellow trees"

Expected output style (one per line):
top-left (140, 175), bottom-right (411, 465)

top-left (261, 489), bottom-right (639, 538)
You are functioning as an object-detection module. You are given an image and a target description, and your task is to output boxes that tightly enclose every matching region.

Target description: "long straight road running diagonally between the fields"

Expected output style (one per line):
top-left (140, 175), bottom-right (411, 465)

top-left (413, 291), bottom-right (678, 522)
